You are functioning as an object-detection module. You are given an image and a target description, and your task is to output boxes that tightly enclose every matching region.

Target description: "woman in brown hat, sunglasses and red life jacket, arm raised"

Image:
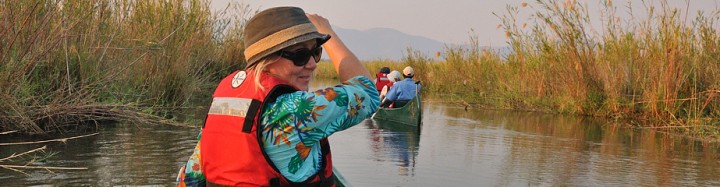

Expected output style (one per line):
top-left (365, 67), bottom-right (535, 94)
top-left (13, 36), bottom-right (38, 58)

top-left (178, 7), bottom-right (380, 186)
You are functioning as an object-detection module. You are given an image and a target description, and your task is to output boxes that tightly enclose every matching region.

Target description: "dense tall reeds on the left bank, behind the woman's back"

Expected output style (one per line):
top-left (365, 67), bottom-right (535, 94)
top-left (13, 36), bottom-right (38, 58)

top-left (0, 0), bottom-right (252, 133)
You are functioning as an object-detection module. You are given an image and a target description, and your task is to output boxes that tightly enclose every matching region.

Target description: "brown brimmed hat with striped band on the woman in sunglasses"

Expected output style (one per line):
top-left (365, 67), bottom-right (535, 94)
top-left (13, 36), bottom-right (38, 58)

top-left (244, 7), bottom-right (330, 69)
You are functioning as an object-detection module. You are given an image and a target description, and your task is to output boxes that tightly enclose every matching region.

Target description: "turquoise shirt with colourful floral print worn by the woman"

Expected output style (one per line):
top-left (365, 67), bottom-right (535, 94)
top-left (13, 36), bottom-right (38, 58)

top-left (261, 76), bottom-right (380, 182)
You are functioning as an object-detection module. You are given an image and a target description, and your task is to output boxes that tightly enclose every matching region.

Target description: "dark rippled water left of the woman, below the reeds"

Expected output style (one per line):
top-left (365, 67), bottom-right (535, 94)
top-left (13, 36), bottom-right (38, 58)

top-left (0, 125), bottom-right (197, 186)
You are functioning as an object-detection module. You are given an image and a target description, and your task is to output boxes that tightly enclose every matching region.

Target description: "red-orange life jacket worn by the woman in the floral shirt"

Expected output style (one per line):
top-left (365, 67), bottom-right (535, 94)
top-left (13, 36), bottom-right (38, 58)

top-left (200, 71), bottom-right (334, 186)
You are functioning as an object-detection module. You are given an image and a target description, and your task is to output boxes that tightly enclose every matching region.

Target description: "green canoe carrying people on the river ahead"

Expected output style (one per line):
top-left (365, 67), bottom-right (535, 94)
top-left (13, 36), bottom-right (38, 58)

top-left (372, 88), bottom-right (422, 127)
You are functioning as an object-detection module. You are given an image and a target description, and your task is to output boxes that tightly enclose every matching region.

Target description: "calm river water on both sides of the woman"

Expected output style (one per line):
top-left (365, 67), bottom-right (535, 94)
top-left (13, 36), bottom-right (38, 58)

top-left (0, 80), bottom-right (720, 187)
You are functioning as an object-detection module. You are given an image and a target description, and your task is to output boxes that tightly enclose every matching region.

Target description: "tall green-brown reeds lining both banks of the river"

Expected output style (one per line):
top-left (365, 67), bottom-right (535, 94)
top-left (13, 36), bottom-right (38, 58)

top-left (0, 0), bottom-right (720, 140)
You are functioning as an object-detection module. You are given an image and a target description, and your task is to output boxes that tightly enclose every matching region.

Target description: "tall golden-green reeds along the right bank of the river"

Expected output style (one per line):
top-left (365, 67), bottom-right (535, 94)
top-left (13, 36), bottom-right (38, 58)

top-left (320, 0), bottom-right (720, 141)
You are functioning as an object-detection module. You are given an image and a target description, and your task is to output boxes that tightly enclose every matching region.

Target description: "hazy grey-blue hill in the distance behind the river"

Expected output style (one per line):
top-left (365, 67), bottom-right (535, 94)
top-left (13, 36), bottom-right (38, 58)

top-left (324, 26), bottom-right (444, 60)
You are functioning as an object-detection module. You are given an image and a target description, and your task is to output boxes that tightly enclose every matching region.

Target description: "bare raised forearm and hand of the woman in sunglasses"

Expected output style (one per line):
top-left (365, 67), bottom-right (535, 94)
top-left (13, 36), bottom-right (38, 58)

top-left (306, 14), bottom-right (372, 81)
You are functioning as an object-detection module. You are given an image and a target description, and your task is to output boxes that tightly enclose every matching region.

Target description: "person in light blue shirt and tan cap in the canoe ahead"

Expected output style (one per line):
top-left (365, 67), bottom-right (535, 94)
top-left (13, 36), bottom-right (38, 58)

top-left (381, 66), bottom-right (421, 108)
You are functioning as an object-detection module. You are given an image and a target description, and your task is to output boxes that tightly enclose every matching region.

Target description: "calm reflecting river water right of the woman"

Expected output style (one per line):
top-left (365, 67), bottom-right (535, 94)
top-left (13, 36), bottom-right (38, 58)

top-left (331, 108), bottom-right (720, 186)
